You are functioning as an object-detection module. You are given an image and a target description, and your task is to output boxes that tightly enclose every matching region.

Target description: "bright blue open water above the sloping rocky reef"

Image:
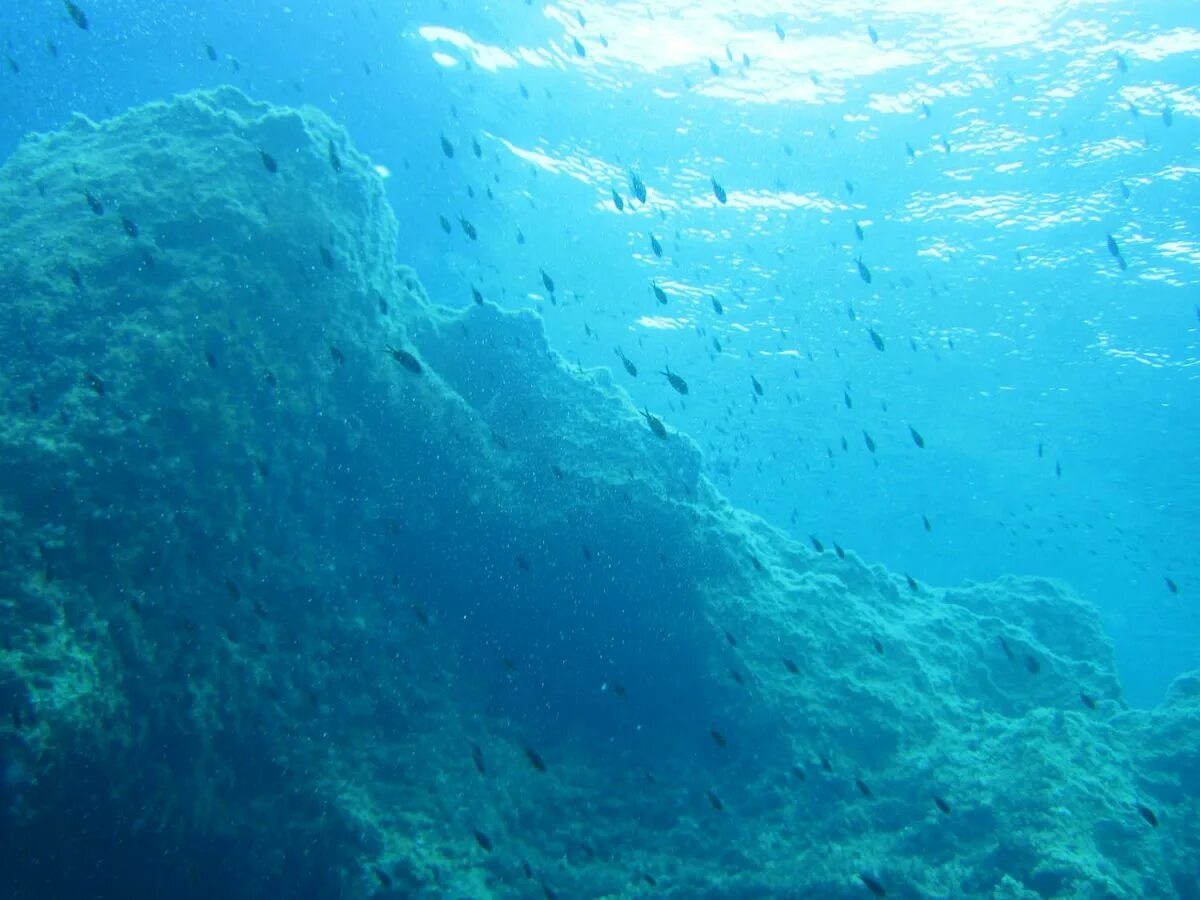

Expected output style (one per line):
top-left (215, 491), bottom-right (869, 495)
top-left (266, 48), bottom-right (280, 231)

top-left (0, 0), bottom-right (1200, 704)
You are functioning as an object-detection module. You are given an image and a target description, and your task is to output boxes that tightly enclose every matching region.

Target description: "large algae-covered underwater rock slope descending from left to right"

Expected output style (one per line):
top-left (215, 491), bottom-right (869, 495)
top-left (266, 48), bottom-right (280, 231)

top-left (0, 89), bottom-right (1200, 898)
